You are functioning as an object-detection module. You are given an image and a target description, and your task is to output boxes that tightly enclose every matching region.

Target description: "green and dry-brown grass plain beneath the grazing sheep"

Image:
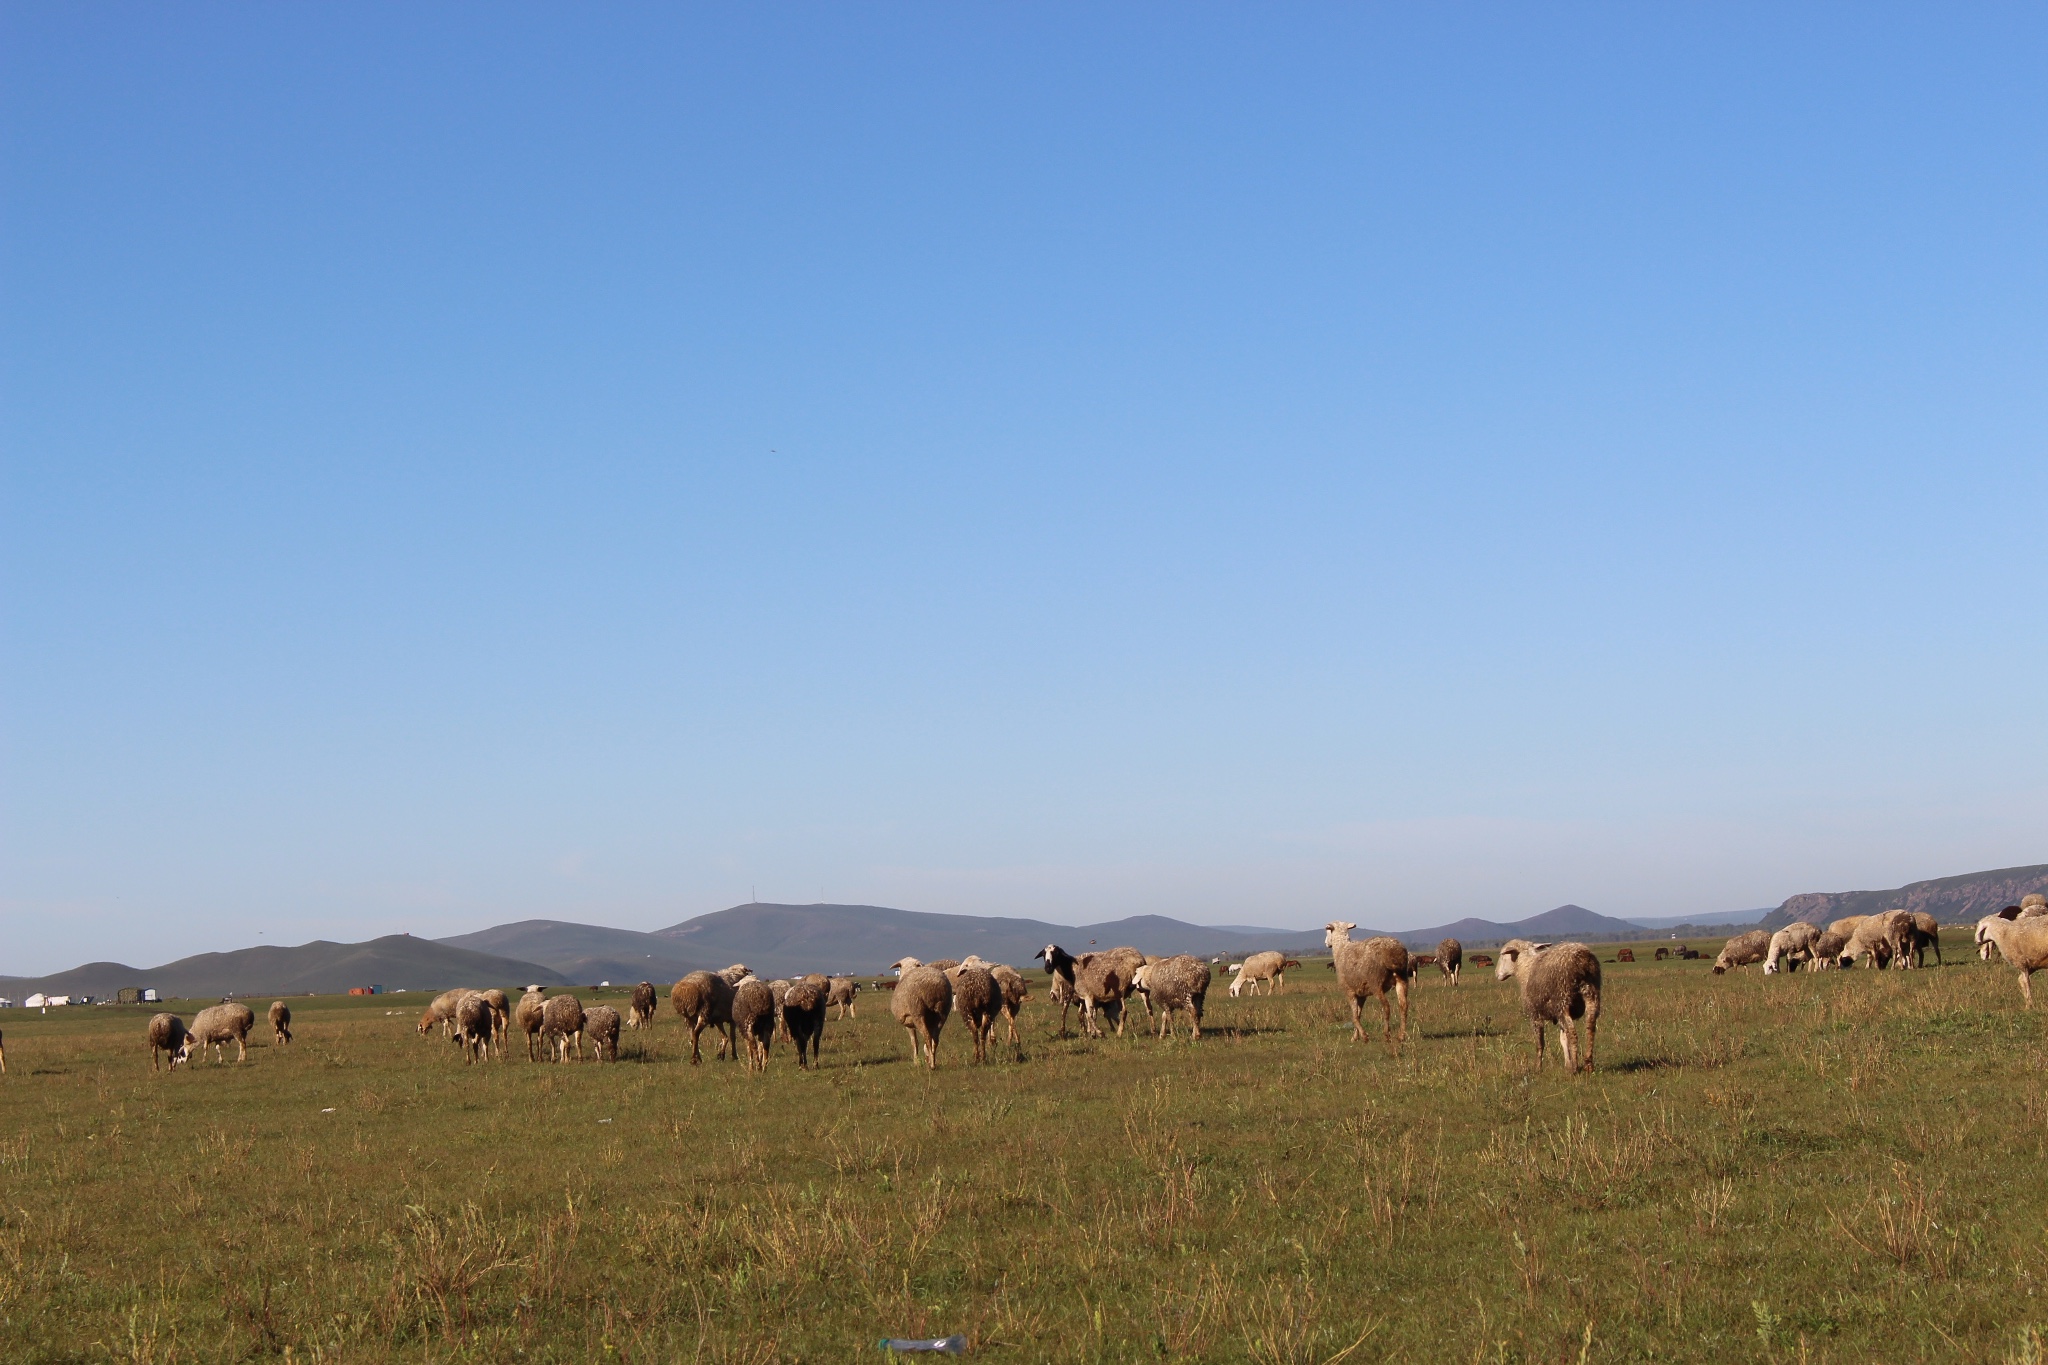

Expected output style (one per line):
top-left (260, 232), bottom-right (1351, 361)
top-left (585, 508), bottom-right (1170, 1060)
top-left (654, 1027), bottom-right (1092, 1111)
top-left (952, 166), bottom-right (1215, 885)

top-left (0, 933), bottom-right (2048, 1365)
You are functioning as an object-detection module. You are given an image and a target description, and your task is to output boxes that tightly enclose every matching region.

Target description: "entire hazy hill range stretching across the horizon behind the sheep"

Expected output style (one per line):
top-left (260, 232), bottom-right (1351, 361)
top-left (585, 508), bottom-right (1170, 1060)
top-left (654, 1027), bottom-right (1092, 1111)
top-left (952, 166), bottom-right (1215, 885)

top-left (0, 864), bottom-right (2048, 999)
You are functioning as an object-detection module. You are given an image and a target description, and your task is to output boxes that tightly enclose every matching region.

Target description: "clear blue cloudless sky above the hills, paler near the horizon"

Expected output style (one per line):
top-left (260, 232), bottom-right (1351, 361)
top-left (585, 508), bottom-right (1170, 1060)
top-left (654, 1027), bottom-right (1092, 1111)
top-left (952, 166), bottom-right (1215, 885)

top-left (0, 2), bottom-right (2048, 972)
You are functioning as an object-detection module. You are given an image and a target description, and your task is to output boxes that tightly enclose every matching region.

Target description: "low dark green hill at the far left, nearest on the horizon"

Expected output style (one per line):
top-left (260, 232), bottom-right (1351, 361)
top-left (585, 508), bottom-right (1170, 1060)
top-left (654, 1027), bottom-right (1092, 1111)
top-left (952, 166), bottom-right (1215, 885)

top-left (0, 933), bottom-right (569, 999)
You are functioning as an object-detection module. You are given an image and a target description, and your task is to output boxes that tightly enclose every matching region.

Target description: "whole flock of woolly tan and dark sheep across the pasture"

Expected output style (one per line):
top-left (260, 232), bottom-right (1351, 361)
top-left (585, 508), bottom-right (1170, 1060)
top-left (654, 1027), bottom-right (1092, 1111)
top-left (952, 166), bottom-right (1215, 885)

top-left (128, 894), bottom-right (2048, 1072)
